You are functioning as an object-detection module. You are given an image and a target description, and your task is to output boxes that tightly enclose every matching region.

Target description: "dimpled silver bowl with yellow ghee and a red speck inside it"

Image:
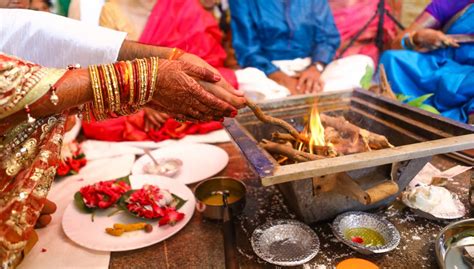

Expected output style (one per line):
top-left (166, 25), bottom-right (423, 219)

top-left (332, 211), bottom-right (400, 254)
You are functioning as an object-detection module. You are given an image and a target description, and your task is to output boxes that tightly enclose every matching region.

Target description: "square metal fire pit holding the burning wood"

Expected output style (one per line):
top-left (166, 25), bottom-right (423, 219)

top-left (224, 89), bottom-right (474, 223)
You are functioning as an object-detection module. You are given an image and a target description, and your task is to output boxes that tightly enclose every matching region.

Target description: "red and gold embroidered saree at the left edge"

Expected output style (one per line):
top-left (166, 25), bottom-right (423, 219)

top-left (0, 53), bottom-right (67, 268)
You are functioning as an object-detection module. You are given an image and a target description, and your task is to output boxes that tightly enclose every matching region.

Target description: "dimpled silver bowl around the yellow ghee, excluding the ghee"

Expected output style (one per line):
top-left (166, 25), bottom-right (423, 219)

top-left (332, 211), bottom-right (400, 255)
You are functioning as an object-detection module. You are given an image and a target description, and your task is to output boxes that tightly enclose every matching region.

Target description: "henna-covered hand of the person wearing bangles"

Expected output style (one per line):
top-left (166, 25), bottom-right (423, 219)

top-left (147, 60), bottom-right (245, 122)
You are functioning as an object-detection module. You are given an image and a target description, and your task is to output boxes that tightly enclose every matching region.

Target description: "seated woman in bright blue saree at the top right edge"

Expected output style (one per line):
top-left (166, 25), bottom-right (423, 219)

top-left (381, 0), bottom-right (474, 122)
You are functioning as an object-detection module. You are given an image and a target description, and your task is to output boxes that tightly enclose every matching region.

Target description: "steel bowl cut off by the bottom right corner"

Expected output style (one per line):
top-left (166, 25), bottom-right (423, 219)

top-left (435, 219), bottom-right (474, 269)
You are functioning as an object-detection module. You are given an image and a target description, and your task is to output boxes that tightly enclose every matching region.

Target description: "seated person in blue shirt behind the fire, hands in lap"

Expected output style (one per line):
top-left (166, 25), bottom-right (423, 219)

top-left (229, 0), bottom-right (373, 94)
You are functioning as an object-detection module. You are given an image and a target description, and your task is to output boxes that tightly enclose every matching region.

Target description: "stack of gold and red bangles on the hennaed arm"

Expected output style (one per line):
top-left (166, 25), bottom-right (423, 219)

top-left (83, 57), bottom-right (158, 122)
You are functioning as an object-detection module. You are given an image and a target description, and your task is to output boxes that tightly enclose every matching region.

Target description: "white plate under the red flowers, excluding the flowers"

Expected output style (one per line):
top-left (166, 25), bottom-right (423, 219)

top-left (62, 175), bottom-right (196, 251)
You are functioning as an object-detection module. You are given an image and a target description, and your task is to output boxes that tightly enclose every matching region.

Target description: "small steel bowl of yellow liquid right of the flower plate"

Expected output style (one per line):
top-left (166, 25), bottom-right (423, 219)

top-left (194, 177), bottom-right (247, 220)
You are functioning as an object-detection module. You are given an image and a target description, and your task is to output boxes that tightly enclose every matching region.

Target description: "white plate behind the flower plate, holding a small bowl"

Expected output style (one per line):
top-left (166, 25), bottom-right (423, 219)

top-left (132, 143), bottom-right (229, 184)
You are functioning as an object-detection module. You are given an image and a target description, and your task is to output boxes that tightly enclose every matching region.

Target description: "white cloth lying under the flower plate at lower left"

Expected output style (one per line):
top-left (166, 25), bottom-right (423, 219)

top-left (18, 154), bottom-right (135, 269)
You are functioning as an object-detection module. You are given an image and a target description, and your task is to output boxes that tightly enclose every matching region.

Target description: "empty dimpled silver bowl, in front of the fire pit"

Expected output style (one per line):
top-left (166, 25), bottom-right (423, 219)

top-left (251, 219), bottom-right (319, 266)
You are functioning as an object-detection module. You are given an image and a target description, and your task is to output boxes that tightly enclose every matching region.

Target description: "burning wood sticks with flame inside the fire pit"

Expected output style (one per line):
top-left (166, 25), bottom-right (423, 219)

top-left (247, 102), bottom-right (393, 163)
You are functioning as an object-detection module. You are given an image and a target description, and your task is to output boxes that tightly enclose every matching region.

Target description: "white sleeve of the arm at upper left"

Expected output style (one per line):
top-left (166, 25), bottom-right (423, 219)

top-left (0, 9), bottom-right (127, 68)
